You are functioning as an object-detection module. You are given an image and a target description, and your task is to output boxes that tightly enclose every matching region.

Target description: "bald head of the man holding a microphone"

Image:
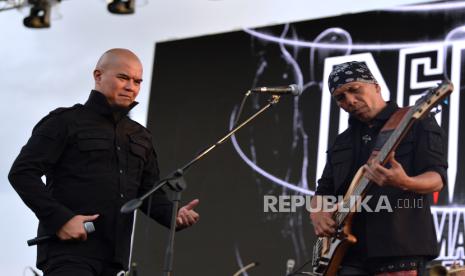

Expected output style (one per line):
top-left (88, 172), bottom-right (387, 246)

top-left (94, 48), bottom-right (142, 107)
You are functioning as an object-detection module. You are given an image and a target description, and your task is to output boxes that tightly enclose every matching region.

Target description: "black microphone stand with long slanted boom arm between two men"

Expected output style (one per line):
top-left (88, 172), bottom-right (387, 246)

top-left (121, 95), bottom-right (281, 276)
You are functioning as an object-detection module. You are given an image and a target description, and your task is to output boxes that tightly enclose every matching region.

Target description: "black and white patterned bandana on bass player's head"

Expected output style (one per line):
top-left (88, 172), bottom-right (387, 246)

top-left (328, 61), bottom-right (378, 94)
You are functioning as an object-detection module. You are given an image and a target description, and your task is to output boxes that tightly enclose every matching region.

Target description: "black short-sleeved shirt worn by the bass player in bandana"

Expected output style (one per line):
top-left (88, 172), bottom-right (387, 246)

top-left (316, 103), bottom-right (447, 259)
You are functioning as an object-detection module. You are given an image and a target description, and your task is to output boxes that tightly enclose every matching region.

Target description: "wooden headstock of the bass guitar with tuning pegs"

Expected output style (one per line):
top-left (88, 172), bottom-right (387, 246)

top-left (412, 81), bottom-right (454, 119)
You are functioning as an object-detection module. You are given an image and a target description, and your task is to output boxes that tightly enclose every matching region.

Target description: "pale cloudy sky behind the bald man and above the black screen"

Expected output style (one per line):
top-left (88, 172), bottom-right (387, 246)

top-left (0, 0), bottom-right (425, 276)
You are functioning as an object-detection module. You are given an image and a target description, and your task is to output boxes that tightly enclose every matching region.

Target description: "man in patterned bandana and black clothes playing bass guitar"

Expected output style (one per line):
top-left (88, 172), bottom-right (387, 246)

top-left (310, 61), bottom-right (447, 275)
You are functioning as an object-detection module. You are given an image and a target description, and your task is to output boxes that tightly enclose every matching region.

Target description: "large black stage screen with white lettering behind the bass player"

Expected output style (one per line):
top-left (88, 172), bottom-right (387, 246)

top-left (133, 2), bottom-right (465, 276)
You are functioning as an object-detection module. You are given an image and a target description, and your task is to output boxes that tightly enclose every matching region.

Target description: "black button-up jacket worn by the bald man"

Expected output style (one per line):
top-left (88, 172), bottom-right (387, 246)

top-left (9, 91), bottom-right (172, 268)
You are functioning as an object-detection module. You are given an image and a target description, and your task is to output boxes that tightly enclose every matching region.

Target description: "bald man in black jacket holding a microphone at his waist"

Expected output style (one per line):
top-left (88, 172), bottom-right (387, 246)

top-left (8, 49), bottom-right (199, 276)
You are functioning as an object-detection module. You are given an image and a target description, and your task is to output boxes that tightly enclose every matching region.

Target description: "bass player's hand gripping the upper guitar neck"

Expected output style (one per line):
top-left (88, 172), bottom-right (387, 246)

top-left (363, 152), bottom-right (409, 189)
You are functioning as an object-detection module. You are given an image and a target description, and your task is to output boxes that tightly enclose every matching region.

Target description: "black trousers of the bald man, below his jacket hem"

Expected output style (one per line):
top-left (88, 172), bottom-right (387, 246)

top-left (43, 255), bottom-right (123, 276)
